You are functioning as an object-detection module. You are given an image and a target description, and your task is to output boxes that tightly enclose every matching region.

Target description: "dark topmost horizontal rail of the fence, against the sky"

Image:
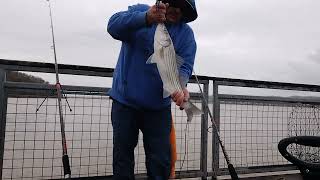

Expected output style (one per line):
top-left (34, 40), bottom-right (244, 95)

top-left (0, 59), bottom-right (320, 92)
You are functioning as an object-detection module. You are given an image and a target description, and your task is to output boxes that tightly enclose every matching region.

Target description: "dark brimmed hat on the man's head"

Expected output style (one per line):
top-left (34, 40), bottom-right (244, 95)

top-left (162, 0), bottom-right (198, 23)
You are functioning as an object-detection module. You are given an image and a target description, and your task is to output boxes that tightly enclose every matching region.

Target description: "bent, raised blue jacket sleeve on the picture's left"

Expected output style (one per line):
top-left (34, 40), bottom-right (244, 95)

top-left (107, 4), bottom-right (149, 41)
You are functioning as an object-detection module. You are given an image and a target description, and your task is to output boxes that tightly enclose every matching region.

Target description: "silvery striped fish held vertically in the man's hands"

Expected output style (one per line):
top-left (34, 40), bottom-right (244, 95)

top-left (146, 23), bottom-right (203, 122)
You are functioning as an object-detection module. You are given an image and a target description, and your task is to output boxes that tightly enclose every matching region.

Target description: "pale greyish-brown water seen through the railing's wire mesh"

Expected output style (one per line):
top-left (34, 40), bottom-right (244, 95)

top-left (2, 95), bottom-right (319, 179)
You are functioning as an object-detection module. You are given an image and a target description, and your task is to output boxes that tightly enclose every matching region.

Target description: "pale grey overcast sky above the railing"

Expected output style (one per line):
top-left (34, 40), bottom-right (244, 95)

top-left (0, 0), bottom-right (320, 89)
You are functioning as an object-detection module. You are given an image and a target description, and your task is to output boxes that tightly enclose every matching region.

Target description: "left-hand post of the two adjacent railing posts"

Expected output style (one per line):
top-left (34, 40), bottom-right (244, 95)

top-left (200, 81), bottom-right (209, 179)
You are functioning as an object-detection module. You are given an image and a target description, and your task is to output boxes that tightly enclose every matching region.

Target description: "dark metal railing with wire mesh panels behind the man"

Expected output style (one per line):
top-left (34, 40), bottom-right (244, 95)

top-left (0, 60), bottom-right (320, 179)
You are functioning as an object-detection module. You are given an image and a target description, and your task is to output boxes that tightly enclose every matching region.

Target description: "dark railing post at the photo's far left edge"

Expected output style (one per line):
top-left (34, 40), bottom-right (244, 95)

top-left (0, 69), bottom-right (7, 179)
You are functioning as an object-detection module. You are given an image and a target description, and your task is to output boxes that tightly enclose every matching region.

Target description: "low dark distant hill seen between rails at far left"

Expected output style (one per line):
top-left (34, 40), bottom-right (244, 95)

top-left (7, 71), bottom-right (49, 84)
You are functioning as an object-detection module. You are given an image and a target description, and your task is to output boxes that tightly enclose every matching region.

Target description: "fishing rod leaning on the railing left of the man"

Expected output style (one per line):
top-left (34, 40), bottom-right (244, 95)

top-left (47, 0), bottom-right (71, 178)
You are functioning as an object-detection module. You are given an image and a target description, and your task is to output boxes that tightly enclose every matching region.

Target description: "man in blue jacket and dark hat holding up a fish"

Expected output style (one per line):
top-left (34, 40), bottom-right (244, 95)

top-left (107, 0), bottom-right (198, 179)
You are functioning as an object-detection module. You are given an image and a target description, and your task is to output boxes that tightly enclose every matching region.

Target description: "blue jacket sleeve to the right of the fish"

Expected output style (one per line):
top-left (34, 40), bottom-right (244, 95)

top-left (177, 28), bottom-right (197, 87)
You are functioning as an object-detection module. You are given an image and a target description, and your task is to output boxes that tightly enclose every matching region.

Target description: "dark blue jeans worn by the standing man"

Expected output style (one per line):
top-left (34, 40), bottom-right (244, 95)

top-left (111, 100), bottom-right (171, 180)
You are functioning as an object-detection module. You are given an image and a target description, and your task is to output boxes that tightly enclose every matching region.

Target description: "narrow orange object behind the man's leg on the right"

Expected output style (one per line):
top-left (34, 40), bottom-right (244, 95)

top-left (169, 118), bottom-right (177, 179)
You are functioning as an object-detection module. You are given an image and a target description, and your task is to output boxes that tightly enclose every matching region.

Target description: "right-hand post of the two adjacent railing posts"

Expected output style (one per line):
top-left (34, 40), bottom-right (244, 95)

top-left (212, 81), bottom-right (220, 179)
